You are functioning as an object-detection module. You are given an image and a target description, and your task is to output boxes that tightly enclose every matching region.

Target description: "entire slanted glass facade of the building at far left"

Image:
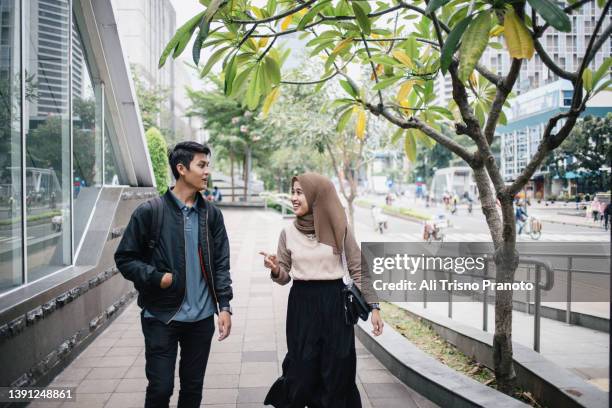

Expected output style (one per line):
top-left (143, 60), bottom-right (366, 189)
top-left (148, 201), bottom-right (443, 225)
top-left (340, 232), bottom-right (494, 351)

top-left (0, 0), bottom-right (125, 294)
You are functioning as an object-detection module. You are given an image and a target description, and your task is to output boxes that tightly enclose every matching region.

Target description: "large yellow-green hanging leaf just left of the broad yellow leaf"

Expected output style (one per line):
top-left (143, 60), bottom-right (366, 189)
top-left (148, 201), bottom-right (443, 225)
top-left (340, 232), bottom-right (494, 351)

top-left (459, 11), bottom-right (491, 83)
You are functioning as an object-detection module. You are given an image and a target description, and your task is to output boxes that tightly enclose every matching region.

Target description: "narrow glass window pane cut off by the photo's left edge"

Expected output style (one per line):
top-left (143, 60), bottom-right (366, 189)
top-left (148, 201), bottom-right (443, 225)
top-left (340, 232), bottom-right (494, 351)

top-left (0, 0), bottom-right (23, 292)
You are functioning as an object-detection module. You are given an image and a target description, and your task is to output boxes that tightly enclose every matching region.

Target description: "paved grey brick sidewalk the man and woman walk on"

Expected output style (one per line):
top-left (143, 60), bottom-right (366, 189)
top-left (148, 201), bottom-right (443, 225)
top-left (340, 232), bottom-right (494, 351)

top-left (30, 209), bottom-right (435, 408)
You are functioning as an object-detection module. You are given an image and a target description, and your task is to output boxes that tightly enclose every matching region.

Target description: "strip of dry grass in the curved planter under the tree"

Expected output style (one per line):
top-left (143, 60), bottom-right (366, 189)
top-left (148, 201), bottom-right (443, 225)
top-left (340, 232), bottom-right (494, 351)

top-left (380, 303), bottom-right (545, 408)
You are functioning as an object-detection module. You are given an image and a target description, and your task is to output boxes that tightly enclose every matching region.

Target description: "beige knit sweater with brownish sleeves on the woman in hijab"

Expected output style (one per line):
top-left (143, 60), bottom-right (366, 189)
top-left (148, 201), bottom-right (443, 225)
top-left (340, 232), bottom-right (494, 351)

top-left (270, 223), bottom-right (378, 303)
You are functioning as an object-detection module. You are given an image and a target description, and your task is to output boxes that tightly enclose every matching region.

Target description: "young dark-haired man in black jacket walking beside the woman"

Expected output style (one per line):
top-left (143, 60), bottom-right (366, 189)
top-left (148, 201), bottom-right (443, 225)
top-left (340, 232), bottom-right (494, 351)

top-left (115, 142), bottom-right (232, 408)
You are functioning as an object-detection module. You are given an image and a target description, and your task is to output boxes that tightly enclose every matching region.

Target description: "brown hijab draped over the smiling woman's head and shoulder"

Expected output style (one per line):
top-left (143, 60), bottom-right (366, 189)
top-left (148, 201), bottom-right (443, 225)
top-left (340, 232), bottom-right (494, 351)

top-left (291, 173), bottom-right (347, 254)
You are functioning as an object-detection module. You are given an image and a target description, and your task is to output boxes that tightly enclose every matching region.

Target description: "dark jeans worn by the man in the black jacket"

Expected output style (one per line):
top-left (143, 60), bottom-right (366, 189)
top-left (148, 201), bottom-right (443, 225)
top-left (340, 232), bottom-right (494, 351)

top-left (140, 313), bottom-right (215, 408)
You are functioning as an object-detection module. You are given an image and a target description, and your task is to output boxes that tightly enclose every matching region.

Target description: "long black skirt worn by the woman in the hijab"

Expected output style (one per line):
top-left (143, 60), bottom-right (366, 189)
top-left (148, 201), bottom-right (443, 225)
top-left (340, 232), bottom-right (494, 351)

top-left (264, 279), bottom-right (361, 408)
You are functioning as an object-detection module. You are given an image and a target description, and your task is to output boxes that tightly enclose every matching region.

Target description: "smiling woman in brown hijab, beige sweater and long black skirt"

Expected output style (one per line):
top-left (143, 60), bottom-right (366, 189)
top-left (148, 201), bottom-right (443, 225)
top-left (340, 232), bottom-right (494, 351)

top-left (261, 173), bottom-right (383, 408)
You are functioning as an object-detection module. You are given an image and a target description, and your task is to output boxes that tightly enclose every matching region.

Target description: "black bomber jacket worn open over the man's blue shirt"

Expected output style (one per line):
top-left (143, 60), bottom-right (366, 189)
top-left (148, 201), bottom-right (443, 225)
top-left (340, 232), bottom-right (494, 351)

top-left (115, 190), bottom-right (233, 322)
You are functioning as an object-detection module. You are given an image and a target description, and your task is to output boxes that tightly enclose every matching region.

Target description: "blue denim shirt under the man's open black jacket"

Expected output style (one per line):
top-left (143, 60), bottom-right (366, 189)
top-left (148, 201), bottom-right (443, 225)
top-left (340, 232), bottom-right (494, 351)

top-left (144, 193), bottom-right (215, 322)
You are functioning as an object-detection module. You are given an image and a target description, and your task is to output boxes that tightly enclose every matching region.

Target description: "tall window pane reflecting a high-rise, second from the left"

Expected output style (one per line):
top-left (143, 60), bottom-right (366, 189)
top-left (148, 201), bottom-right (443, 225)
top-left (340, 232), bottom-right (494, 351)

top-left (24, 0), bottom-right (72, 282)
